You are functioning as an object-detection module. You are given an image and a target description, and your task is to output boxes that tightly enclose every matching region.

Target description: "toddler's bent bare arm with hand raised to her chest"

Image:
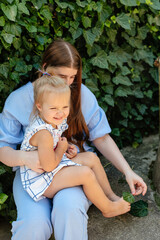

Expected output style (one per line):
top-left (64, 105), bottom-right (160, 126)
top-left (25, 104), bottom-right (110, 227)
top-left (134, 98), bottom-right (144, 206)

top-left (30, 129), bottom-right (68, 172)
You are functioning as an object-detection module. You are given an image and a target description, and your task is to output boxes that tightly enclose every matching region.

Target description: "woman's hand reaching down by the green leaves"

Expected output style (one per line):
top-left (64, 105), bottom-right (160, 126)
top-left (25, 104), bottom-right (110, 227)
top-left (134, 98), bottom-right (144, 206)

top-left (125, 170), bottom-right (147, 196)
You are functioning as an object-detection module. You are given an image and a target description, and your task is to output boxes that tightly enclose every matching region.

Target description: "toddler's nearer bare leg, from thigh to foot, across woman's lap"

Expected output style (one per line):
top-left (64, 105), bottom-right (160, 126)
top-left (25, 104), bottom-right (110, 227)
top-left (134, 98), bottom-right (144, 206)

top-left (44, 166), bottom-right (130, 217)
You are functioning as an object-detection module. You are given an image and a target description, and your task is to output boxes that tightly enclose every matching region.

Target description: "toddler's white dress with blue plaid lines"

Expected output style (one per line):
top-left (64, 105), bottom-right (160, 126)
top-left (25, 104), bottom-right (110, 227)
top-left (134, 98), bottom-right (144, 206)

top-left (20, 116), bottom-right (80, 201)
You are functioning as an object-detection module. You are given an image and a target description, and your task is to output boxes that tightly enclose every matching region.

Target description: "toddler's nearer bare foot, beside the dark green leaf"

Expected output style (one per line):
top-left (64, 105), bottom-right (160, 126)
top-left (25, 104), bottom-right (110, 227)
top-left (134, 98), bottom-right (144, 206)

top-left (102, 198), bottom-right (131, 218)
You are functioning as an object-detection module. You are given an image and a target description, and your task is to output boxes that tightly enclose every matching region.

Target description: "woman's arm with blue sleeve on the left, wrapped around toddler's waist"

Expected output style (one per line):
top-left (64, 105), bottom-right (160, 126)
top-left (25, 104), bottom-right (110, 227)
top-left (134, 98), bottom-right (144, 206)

top-left (0, 83), bottom-right (43, 173)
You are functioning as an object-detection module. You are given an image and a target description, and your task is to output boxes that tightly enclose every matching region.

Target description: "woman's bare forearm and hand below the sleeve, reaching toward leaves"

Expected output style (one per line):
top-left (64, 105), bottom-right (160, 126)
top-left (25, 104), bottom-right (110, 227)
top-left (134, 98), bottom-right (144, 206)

top-left (93, 134), bottom-right (147, 195)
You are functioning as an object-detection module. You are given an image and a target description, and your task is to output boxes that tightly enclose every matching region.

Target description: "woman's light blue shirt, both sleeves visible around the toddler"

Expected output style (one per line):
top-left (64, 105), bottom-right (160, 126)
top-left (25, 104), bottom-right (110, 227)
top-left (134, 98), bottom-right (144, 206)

top-left (0, 82), bottom-right (111, 149)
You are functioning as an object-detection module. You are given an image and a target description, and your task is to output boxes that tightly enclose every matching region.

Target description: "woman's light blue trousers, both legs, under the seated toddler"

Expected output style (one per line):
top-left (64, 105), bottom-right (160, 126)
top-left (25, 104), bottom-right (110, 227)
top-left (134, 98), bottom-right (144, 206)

top-left (11, 170), bottom-right (91, 240)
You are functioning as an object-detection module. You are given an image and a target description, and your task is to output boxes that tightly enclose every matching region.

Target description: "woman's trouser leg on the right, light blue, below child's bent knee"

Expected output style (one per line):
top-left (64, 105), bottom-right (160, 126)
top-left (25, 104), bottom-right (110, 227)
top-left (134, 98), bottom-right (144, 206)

top-left (51, 186), bottom-right (91, 240)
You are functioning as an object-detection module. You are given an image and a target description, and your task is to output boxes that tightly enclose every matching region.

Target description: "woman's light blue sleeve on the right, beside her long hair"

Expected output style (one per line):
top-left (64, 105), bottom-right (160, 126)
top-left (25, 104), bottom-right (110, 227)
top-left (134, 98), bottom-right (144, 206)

top-left (81, 84), bottom-right (111, 141)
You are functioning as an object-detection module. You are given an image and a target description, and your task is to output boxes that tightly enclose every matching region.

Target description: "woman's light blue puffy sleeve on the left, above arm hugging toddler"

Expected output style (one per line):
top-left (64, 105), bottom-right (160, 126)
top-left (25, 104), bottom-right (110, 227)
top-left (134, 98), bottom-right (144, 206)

top-left (0, 83), bottom-right (33, 149)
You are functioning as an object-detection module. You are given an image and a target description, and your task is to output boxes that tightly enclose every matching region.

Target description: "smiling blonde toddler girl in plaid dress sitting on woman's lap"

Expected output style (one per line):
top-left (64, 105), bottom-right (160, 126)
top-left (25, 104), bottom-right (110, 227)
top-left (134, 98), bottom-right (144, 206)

top-left (20, 72), bottom-right (130, 217)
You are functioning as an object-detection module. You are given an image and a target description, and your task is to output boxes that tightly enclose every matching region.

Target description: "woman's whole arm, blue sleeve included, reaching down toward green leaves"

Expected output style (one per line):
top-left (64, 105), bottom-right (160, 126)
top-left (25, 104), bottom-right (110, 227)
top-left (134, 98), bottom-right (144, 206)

top-left (81, 84), bottom-right (147, 195)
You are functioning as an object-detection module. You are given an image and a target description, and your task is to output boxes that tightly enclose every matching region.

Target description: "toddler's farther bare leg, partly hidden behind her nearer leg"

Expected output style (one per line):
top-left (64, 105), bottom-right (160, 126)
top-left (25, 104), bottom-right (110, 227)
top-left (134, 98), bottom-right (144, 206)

top-left (72, 152), bottom-right (120, 201)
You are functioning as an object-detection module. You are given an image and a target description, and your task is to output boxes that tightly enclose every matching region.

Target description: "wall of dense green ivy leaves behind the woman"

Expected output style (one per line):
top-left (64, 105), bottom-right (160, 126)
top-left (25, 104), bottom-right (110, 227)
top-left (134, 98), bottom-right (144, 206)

top-left (0, 0), bottom-right (160, 218)
